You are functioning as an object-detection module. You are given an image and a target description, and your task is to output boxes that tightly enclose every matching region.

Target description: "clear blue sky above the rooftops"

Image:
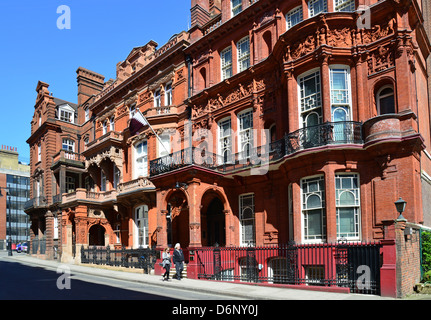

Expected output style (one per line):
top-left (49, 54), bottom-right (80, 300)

top-left (0, 0), bottom-right (190, 162)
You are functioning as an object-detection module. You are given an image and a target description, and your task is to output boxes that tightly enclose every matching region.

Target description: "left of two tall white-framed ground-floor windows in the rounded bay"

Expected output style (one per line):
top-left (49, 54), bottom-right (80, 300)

top-left (301, 175), bottom-right (326, 243)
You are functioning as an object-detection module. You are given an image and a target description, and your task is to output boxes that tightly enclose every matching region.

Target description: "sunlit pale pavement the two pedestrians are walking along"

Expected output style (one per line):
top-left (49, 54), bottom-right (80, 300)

top-left (0, 251), bottom-right (395, 300)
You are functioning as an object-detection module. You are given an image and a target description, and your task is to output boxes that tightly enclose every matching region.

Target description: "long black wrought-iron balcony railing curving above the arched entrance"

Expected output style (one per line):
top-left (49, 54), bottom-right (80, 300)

top-left (150, 121), bottom-right (363, 176)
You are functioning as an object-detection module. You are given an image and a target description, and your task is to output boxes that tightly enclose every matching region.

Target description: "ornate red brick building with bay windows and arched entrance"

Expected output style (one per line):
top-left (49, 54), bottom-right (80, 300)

top-left (27, 0), bottom-right (431, 298)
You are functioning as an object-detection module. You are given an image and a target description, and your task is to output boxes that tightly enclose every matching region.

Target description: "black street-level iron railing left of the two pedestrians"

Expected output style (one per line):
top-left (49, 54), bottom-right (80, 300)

top-left (81, 246), bottom-right (160, 273)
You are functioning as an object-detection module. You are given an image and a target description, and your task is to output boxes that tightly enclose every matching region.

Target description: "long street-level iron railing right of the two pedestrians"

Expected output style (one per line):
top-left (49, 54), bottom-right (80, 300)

top-left (194, 243), bottom-right (381, 294)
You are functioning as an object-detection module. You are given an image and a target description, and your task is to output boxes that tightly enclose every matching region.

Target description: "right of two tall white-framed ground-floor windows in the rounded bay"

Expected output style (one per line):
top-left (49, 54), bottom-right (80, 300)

top-left (335, 172), bottom-right (361, 240)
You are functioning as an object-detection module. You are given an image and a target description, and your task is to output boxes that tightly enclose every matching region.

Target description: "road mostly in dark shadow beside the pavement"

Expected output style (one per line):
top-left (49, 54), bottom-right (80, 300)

top-left (0, 259), bottom-right (243, 300)
